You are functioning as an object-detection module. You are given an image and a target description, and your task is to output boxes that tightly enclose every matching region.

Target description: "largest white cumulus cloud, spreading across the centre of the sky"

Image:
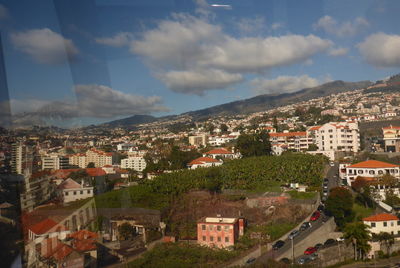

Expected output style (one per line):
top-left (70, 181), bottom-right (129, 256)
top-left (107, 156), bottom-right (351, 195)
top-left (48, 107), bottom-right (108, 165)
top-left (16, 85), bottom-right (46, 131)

top-left (130, 14), bottom-right (333, 94)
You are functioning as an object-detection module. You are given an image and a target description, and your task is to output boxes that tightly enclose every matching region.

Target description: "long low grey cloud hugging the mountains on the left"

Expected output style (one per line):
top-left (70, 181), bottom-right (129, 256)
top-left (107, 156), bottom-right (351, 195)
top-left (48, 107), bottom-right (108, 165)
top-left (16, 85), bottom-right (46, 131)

top-left (10, 84), bottom-right (168, 119)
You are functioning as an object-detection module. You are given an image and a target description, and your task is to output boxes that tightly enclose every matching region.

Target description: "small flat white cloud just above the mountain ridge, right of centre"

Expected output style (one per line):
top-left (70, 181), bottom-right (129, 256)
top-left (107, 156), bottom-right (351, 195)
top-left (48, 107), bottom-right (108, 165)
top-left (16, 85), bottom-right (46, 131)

top-left (251, 75), bottom-right (320, 94)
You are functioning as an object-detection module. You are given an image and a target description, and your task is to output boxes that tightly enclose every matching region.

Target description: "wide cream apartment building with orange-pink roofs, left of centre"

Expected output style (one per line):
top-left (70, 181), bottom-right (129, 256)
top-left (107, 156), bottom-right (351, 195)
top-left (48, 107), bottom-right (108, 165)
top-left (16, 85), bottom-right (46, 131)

top-left (69, 148), bottom-right (113, 168)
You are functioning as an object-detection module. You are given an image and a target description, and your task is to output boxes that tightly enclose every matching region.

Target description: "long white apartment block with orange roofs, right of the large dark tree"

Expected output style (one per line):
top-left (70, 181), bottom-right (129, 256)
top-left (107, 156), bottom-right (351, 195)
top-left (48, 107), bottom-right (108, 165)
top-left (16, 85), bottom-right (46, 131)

top-left (269, 131), bottom-right (313, 151)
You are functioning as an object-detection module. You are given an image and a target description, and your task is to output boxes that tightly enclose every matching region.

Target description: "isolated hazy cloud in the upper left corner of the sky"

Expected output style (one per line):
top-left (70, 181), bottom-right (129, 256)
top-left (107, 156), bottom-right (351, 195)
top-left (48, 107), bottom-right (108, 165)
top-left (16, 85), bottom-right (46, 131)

top-left (11, 28), bottom-right (79, 64)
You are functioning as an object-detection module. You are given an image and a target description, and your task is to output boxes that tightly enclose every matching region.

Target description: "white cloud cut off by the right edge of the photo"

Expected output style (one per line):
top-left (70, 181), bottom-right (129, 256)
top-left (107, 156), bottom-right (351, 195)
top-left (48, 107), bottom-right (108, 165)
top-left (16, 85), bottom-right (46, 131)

top-left (357, 33), bottom-right (400, 67)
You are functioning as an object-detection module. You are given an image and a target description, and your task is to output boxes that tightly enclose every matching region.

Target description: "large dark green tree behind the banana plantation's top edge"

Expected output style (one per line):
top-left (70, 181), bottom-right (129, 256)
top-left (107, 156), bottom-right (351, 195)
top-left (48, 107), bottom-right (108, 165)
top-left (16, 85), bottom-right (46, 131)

top-left (236, 131), bottom-right (271, 157)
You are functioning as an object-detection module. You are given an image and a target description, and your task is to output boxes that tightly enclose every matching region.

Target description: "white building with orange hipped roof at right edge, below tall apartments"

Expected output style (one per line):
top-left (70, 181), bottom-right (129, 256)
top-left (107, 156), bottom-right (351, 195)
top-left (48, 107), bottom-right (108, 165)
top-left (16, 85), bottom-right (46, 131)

top-left (345, 160), bottom-right (400, 185)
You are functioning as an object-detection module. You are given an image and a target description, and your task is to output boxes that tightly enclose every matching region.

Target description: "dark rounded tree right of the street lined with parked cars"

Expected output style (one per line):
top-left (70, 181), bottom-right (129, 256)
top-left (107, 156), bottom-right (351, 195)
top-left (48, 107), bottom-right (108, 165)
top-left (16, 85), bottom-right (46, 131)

top-left (326, 187), bottom-right (355, 229)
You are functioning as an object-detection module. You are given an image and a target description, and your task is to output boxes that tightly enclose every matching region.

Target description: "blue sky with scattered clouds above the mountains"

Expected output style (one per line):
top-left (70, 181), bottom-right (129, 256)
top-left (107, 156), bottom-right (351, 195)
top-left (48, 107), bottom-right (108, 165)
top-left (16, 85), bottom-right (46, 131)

top-left (0, 0), bottom-right (400, 127)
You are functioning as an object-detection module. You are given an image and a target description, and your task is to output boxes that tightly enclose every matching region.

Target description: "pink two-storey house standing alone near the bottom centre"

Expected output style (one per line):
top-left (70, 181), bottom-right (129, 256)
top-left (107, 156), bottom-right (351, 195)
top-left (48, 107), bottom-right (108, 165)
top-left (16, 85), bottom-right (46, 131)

top-left (197, 217), bottom-right (244, 248)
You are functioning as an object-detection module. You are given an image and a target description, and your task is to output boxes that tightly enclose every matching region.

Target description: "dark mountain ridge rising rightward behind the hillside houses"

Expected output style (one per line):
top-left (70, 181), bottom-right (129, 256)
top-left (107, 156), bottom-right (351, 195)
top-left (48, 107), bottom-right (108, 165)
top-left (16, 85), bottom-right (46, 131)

top-left (185, 80), bottom-right (372, 119)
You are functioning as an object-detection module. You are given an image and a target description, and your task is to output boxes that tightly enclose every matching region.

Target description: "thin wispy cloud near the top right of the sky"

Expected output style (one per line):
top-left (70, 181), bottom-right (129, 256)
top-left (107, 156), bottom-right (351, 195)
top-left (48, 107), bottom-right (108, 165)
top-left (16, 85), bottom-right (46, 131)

top-left (313, 16), bottom-right (369, 37)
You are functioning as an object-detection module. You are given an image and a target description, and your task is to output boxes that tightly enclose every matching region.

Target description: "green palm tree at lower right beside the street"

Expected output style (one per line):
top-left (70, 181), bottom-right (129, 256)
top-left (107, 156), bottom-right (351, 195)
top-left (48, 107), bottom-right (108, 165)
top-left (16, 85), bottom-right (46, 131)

top-left (343, 222), bottom-right (371, 260)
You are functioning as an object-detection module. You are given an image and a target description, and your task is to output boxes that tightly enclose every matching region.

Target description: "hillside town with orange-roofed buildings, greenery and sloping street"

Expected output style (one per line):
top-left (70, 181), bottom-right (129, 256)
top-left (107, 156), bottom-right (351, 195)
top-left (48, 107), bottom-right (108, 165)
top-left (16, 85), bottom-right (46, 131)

top-left (0, 76), bottom-right (400, 267)
